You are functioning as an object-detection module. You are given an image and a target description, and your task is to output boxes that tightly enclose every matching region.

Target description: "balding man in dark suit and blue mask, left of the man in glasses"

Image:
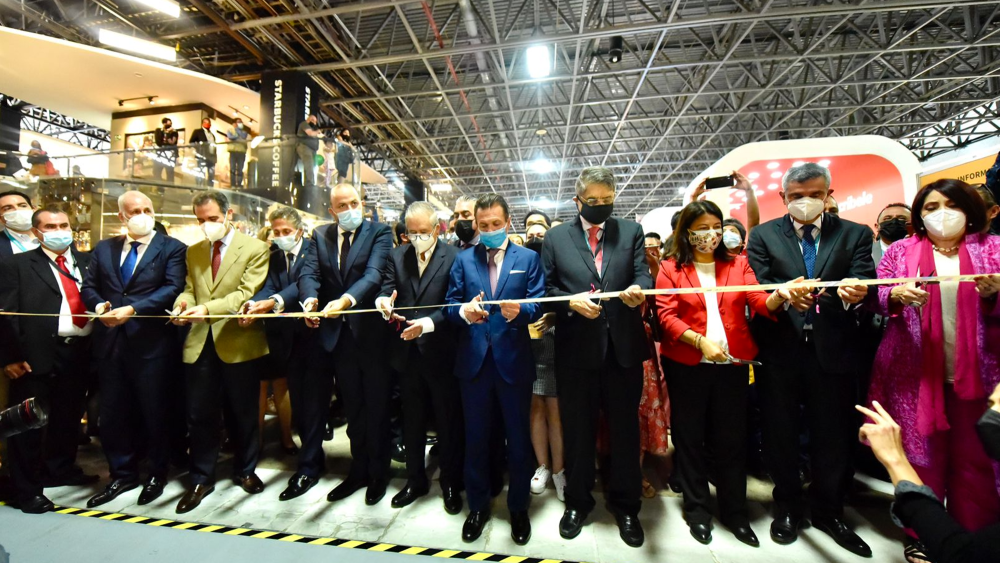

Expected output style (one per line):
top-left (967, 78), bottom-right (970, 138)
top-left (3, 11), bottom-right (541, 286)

top-left (291, 184), bottom-right (392, 505)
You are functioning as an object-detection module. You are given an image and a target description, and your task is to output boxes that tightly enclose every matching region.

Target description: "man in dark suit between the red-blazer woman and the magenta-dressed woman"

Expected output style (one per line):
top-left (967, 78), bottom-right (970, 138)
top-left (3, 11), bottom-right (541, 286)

top-left (747, 163), bottom-right (875, 557)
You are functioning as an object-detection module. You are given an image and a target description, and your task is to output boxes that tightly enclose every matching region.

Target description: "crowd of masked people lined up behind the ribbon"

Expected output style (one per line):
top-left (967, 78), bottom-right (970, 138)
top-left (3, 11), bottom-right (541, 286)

top-left (0, 160), bottom-right (1000, 561)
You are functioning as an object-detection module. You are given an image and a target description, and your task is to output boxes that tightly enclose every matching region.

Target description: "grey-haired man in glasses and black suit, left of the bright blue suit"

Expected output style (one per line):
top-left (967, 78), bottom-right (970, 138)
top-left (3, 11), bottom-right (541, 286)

top-left (376, 201), bottom-right (463, 514)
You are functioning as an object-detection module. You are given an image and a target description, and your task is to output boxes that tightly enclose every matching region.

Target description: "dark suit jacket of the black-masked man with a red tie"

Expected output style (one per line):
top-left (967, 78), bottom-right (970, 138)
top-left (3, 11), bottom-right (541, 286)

top-left (542, 216), bottom-right (653, 369)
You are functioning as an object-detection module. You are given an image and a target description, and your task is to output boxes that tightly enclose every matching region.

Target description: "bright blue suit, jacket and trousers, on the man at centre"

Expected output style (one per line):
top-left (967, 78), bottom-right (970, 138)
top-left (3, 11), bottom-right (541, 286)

top-left (445, 242), bottom-right (545, 512)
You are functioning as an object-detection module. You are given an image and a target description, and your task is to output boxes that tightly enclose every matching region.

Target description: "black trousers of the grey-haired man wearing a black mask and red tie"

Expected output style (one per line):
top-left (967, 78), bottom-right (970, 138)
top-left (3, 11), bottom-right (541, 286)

top-left (556, 341), bottom-right (642, 515)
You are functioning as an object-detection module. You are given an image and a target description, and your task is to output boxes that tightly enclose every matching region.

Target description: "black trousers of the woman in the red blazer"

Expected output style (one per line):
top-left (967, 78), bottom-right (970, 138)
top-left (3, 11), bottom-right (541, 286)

top-left (663, 358), bottom-right (750, 526)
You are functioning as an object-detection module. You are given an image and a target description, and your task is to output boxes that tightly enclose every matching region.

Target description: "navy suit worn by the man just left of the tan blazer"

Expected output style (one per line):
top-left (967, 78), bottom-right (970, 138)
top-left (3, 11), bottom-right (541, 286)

top-left (80, 234), bottom-right (187, 480)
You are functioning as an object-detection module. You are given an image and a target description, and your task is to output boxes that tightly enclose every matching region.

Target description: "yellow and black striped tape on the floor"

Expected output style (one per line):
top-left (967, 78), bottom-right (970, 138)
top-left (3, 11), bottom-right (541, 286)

top-left (50, 506), bottom-right (577, 563)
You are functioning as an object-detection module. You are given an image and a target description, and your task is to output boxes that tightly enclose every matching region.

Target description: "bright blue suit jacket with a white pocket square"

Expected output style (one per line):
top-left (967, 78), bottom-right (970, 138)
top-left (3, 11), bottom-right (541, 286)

top-left (445, 242), bottom-right (545, 384)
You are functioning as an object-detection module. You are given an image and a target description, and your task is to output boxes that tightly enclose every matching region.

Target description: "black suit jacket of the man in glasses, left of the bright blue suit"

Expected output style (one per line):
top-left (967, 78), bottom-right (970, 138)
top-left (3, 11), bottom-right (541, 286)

top-left (379, 242), bottom-right (459, 376)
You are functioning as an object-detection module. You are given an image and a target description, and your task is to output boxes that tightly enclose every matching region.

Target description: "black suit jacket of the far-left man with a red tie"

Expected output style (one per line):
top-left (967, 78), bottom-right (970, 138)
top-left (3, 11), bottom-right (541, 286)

top-left (0, 247), bottom-right (90, 374)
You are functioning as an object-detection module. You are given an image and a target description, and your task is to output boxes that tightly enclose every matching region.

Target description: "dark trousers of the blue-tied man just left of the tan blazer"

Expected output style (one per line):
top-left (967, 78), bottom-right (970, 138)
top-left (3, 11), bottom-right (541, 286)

top-left (97, 335), bottom-right (170, 480)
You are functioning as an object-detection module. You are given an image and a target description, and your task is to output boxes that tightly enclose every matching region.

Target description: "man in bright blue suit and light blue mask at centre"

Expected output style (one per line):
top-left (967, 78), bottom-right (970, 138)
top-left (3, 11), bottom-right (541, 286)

top-left (445, 194), bottom-right (545, 545)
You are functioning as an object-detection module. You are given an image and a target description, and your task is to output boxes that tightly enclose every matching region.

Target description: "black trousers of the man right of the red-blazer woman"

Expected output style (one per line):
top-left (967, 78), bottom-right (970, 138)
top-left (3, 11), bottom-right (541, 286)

top-left (760, 340), bottom-right (857, 518)
